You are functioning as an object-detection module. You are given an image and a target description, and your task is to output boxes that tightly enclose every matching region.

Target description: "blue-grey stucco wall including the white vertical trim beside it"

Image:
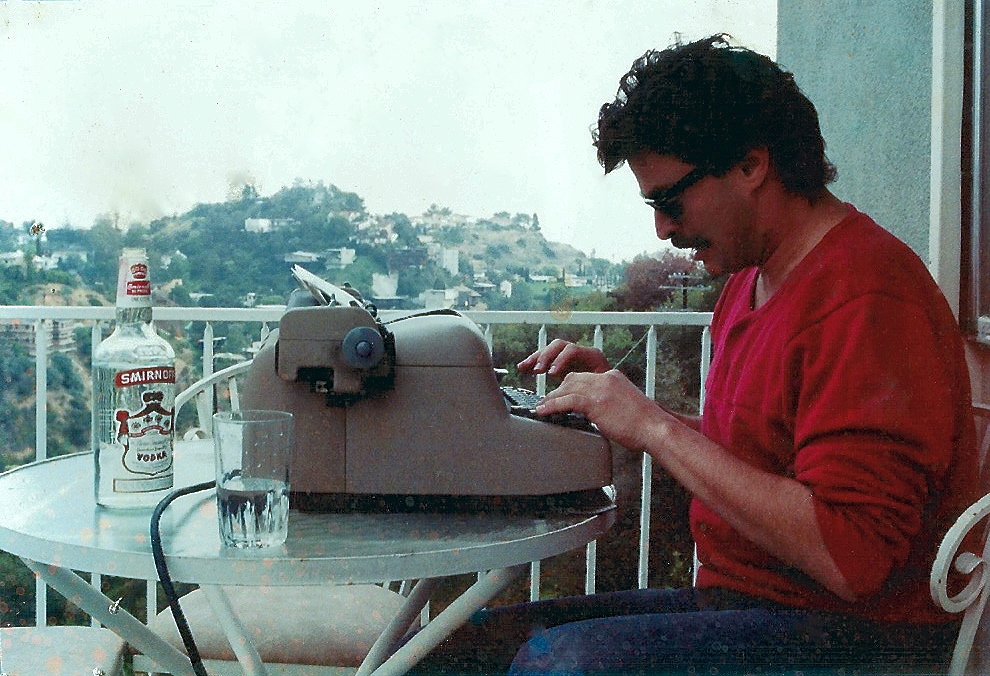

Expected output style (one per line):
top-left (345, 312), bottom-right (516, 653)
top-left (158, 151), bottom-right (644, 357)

top-left (777, 0), bottom-right (965, 308)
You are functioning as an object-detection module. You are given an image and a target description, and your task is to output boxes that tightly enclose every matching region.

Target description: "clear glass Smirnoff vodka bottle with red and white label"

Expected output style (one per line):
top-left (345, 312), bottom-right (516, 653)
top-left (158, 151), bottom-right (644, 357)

top-left (92, 249), bottom-right (175, 507)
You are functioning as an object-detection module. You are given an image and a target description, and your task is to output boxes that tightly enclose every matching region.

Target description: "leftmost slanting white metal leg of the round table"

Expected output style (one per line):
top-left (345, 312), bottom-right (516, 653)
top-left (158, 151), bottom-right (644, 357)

top-left (21, 558), bottom-right (196, 676)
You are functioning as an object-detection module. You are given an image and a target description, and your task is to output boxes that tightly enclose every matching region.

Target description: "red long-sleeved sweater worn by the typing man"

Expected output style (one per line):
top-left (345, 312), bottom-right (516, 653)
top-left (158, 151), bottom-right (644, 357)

top-left (691, 207), bottom-right (978, 623)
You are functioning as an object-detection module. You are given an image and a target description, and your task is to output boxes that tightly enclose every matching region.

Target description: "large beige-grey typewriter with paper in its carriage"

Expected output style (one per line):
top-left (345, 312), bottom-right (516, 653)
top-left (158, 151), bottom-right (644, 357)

top-left (241, 266), bottom-right (614, 512)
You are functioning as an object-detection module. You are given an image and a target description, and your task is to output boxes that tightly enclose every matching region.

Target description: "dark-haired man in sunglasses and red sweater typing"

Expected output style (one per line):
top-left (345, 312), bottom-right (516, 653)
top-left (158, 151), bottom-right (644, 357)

top-left (414, 36), bottom-right (977, 673)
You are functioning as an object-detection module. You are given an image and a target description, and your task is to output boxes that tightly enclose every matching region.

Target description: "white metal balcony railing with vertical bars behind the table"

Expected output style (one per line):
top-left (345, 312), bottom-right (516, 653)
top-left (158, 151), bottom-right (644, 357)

top-left (0, 306), bottom-right (711, 625)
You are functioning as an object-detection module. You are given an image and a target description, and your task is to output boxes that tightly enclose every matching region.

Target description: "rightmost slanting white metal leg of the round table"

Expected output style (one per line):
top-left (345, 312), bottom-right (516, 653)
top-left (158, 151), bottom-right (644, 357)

top-left (364, 563), bottom-right (529, 676)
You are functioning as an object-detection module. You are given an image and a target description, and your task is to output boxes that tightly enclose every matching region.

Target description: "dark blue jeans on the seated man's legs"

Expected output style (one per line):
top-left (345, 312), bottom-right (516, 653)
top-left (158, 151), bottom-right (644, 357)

top-left (414, 589), bottom-right (958, 675)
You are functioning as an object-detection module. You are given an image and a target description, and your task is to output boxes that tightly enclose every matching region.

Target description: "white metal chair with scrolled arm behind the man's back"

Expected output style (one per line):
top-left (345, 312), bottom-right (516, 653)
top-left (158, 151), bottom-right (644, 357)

top-left (929, 404), bottom-right (990, 675)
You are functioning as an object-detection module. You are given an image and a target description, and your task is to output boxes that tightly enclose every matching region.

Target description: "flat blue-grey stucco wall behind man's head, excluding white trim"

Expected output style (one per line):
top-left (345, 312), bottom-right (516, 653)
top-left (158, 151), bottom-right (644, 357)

top-left (777, 0), bottom-right (932, 262)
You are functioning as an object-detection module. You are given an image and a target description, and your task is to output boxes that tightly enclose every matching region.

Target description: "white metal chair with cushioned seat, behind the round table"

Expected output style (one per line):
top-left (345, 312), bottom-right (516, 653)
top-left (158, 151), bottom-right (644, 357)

top-left (134, 361), bottom-right (405, 676)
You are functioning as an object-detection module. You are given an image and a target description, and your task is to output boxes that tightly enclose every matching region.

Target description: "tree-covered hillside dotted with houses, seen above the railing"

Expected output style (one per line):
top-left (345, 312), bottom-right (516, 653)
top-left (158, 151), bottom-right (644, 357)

top-left (25, 183), bottom-right (621, 309)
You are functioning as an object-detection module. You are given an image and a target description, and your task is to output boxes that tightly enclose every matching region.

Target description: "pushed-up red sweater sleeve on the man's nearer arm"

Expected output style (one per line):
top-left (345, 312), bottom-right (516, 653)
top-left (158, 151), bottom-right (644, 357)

top-left (785, 295), bottom-right (957, 598)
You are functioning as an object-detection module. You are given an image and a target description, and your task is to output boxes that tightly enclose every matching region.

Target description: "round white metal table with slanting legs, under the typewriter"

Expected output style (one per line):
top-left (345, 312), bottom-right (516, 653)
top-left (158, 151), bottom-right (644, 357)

top-left (0, 440), bottom-right (614, 676)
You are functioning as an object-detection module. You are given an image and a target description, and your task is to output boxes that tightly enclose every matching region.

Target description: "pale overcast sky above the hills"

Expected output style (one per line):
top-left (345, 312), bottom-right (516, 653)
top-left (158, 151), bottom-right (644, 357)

top-left (0, 0), bottom-right (776, 260)
